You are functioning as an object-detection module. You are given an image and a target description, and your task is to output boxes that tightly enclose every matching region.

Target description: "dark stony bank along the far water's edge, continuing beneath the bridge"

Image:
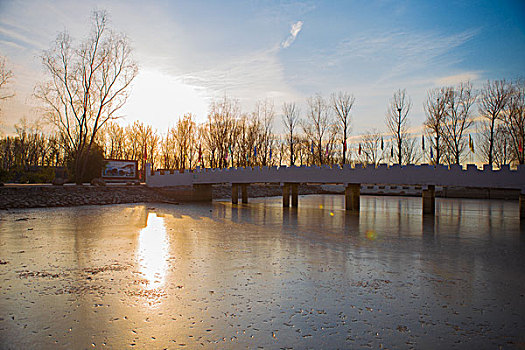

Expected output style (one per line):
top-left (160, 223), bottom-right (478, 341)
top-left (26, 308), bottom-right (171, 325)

top-left (0, 184), bottom-right (519, 210)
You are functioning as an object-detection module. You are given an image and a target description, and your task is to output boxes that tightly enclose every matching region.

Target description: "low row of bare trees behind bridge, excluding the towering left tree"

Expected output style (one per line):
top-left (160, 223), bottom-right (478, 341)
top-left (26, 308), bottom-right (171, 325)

top-left (0, 80), bottom-right (525, 182)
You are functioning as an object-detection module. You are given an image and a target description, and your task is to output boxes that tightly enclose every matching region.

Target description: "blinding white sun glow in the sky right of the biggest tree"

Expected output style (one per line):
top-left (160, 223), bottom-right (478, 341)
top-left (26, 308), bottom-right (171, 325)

top-left (122, 68), bottom-right (208, 133)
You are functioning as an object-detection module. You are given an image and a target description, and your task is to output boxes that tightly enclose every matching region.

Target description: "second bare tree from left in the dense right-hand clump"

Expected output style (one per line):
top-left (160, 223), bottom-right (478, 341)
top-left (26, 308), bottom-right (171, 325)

top-left (443, 82), bottom-right (476, 164)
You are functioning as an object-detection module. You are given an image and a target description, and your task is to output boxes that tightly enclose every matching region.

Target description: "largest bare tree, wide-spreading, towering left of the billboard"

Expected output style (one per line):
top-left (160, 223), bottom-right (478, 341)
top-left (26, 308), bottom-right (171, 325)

top-left (35, 11), bottom-right (138, 183)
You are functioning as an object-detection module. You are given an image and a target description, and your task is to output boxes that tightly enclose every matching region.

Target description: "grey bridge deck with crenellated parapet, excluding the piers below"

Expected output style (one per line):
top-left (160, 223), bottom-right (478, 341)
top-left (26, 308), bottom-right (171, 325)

top-left (146, 164), bottom-right (525, 193)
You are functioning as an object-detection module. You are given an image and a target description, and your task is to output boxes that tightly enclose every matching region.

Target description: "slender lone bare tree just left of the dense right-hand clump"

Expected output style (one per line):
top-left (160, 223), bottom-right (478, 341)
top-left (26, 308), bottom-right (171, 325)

top-left (385, 89), bottom-right (412, 165)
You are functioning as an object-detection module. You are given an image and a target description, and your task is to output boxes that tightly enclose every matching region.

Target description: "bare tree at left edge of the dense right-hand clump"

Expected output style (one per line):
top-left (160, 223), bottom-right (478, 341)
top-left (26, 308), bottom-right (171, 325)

top-left (424, 88), bottom-right (450, 164)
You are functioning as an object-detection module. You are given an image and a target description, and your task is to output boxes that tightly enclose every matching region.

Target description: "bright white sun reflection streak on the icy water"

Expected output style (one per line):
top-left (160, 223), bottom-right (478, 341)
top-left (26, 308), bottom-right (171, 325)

top-left (138, 213), bottom-right (169, 290)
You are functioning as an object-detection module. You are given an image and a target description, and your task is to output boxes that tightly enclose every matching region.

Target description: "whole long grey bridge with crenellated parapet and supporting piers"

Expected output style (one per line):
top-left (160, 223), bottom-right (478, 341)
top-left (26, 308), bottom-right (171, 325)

top-left (146, 164), bottom-right (525, 217)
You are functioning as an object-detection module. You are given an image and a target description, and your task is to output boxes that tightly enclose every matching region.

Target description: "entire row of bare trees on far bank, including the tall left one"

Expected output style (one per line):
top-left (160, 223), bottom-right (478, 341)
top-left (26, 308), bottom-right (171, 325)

top-left (0, 11), bottom-right (525, 183)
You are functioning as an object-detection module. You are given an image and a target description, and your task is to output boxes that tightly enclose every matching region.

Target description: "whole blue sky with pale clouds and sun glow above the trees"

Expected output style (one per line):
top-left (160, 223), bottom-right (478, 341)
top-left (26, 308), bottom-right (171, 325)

top-left (0, 0), bottom-right (525, 135)
